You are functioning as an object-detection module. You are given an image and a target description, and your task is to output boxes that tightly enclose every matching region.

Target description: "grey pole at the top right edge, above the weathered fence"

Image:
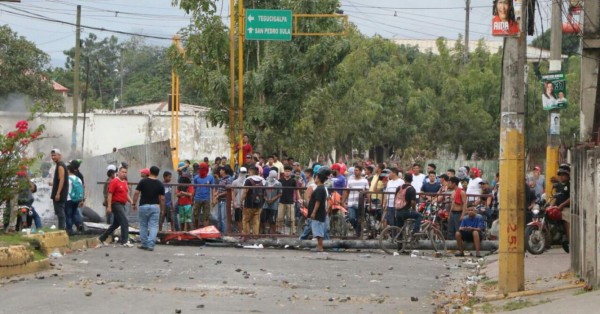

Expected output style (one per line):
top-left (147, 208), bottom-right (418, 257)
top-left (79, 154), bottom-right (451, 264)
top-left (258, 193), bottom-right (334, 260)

top-left (580, 0), bottom-right (600, 142)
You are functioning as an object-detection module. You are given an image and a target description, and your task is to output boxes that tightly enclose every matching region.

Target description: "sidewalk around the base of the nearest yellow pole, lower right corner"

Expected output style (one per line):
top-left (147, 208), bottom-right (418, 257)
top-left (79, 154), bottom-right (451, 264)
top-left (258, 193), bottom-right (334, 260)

top-left (475, 248), bottom-right (600, 314)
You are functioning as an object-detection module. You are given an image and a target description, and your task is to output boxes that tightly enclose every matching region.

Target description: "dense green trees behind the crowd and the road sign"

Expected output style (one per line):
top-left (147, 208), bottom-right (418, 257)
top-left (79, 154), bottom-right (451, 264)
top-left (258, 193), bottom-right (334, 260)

top-left (164, 0), bottom-right (579, 159)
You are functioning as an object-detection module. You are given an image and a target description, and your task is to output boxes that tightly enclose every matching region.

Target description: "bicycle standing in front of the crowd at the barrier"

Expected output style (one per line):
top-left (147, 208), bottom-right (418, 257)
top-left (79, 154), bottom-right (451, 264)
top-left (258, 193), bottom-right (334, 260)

top-left (379, 208), bottom-right (446, 254)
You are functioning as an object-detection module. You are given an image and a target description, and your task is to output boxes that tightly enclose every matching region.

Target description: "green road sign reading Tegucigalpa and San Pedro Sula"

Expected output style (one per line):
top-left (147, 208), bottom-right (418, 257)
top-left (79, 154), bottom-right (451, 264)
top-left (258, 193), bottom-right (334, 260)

top-left (245, 9), bottom-right (292, 41)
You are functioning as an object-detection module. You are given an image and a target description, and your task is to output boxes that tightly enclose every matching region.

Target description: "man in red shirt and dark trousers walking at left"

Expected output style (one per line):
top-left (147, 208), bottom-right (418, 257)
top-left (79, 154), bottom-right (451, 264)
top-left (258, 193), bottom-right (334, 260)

top-left (97, 167), bottom-right (133, 247)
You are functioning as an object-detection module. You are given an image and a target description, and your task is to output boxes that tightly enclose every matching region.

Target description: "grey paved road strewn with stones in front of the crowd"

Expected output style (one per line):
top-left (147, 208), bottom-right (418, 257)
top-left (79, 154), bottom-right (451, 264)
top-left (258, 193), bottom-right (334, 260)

top-left (0, 246), bottom-right (464, 314)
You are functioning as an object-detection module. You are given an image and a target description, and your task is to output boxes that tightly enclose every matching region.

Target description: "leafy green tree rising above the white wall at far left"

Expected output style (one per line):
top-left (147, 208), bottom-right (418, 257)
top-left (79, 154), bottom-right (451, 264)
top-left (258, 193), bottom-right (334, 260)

top-left (0, 25), bottom-right (58, 110)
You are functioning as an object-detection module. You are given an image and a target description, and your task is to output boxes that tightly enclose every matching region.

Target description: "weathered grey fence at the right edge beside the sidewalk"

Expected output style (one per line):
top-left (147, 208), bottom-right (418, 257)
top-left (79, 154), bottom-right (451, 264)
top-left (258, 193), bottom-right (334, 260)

top-left (571, 147), bottom-right (600, 287)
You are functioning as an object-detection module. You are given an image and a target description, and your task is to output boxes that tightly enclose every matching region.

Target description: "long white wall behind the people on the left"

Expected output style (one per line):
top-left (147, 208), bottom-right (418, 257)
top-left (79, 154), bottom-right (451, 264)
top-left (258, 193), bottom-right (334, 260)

top-left (0, 110), bottom-right (229, 160)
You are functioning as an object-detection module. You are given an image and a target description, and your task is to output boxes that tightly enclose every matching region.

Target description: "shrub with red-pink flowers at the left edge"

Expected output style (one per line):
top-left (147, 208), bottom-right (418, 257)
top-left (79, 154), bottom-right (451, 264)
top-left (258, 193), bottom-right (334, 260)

top-left (0, 120), bottom-right (44, 204)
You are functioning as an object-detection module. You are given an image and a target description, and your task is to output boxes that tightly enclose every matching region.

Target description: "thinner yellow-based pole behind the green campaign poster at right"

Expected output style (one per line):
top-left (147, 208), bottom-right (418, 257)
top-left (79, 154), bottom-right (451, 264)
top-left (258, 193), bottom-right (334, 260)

top-left (546, 0), bottom-right (563, 193)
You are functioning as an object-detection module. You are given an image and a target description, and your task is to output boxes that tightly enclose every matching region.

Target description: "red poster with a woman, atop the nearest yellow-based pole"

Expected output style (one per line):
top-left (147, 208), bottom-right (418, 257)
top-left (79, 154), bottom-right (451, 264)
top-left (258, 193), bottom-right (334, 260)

top-left (492, 0), bottom-right (522, 37)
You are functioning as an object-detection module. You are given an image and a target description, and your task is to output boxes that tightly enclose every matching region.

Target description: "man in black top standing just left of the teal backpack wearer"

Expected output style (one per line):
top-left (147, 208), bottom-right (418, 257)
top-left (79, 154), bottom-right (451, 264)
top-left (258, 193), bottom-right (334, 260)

top-left (50, 148), bottom-right (69, 230)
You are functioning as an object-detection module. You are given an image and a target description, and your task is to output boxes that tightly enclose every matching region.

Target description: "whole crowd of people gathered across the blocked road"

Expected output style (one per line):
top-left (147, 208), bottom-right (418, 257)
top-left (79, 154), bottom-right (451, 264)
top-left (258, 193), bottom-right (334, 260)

top-left (3, 141), bottom-right (570, 254)
